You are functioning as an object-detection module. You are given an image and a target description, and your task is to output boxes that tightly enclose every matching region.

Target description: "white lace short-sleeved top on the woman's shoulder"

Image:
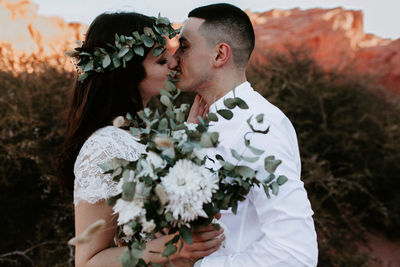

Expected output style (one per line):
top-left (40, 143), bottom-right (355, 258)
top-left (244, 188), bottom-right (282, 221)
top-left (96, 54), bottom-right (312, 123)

top-left (74, 126), bottom-right (146, 206)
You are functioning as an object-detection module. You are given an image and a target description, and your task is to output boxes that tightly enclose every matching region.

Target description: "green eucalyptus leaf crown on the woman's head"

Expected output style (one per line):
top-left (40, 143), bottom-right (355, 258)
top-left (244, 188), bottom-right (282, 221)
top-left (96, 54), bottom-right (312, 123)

top-left (65, 14), bottom-right (180, 82)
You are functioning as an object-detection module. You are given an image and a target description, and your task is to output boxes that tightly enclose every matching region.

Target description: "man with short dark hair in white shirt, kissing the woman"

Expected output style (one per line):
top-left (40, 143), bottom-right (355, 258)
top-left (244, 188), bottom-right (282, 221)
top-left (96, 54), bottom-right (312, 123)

top-left (174, 4), bottom-right (318, 267)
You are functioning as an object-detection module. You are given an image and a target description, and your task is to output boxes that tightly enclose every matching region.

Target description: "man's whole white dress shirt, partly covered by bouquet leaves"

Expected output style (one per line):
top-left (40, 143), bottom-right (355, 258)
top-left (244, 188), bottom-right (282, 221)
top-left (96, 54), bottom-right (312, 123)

top-left (201, 82), bottom-right (318, 267)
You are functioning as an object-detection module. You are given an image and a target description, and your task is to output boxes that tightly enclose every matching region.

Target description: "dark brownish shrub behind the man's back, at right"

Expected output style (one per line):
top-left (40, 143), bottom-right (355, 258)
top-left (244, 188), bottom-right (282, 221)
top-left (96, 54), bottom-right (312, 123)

top-left (248, 49), bottom-right (400, 266)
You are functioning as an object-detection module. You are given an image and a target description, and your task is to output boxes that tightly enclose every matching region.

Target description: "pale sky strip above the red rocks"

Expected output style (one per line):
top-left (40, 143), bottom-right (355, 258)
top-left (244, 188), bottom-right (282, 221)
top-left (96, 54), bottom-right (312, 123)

top-left (32, 0), bottom-right (400, 39)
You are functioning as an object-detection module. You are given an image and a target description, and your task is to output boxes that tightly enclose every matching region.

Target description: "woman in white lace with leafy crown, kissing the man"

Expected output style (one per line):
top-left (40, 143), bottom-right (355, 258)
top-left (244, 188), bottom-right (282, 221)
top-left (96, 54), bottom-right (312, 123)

top-left (59, 13), bottom-right (224, 266)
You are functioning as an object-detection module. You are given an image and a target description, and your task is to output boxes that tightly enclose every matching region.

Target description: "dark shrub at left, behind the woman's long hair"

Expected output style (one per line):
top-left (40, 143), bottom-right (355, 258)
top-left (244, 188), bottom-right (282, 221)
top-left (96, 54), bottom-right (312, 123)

top-left (0, 68), bottom-right (73, 266)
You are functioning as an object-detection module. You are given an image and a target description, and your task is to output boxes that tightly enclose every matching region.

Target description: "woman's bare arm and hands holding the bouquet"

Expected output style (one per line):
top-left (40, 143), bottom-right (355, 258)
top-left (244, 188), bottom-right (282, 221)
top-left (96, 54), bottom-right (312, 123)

top-left (75, 201), bottom-right (224, 267)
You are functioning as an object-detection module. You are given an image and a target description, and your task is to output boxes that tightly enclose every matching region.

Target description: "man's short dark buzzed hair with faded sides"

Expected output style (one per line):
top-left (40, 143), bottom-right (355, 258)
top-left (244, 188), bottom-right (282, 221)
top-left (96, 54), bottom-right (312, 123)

top-left (188, 4), bottom-right (254, 68)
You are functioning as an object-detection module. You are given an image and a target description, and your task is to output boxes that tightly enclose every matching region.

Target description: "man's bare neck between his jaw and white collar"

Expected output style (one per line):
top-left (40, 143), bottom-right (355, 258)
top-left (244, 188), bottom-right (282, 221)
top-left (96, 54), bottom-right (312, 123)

top-left (198, 72), bottom-right (247, 106)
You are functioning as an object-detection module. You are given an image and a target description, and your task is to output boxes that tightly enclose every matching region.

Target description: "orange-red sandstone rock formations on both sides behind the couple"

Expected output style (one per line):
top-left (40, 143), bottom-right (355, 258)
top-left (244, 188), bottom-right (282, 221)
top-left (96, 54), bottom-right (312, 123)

top-left (0, 0), bottom-right (400, 94)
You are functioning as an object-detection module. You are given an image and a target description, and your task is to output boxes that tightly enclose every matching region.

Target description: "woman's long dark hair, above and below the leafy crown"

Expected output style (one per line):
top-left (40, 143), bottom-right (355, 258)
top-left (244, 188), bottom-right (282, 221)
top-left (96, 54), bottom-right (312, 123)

top-left (56, 12), bottom-right (153, 194)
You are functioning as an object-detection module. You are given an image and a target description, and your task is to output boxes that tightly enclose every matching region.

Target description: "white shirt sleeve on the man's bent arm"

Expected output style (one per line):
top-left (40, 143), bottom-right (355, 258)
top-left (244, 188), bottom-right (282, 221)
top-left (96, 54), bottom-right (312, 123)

top-left (201, 118), bottom-right (318, 267)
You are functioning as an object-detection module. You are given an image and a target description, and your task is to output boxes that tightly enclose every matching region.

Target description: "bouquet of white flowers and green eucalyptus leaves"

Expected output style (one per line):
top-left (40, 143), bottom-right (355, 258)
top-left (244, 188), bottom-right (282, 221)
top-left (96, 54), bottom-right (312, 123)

top-left (99, 77), bottom-right (287, 266)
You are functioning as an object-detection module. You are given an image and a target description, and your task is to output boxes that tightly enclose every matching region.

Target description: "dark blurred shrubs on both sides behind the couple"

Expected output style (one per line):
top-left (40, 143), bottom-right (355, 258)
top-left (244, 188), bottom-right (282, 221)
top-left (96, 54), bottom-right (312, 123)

top-left (0, 49), bottom-right (400, 266)
